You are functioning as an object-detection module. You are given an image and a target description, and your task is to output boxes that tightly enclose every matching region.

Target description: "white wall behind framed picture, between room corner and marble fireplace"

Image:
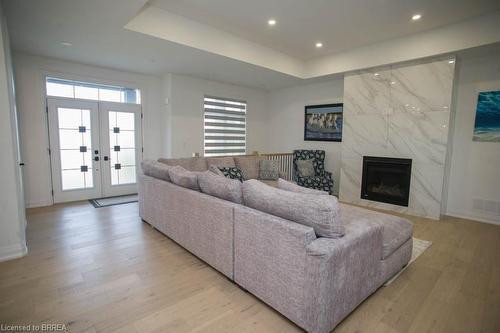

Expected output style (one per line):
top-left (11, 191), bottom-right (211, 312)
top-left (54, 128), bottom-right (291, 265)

top-left (266, 79), bottom-right (344, 194)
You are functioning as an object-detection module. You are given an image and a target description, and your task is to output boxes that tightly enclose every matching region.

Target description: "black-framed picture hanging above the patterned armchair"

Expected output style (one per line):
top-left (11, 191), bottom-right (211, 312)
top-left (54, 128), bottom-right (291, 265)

top-left (304, 103), bottom-right (344, 142)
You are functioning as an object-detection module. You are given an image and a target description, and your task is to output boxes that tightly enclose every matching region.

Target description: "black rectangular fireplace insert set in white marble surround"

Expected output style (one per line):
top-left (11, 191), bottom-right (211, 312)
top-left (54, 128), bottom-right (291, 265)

top-left (361, 156), bottom-right (411, 207)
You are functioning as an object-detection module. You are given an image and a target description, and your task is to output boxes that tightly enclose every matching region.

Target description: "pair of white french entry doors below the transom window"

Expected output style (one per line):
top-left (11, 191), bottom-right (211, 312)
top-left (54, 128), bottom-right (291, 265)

top-left (47, 97), bottom-right (142, 203)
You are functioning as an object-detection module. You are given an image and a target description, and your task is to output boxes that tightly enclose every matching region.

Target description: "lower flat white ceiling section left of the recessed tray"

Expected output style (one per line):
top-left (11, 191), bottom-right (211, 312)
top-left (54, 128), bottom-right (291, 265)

top-left (2, 0), bottom-right (300, 89)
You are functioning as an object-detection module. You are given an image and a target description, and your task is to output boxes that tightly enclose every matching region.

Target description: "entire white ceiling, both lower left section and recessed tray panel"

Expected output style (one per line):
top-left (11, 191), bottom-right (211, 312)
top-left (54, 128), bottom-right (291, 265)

top-left (2, 0), bottom-right (500, 89)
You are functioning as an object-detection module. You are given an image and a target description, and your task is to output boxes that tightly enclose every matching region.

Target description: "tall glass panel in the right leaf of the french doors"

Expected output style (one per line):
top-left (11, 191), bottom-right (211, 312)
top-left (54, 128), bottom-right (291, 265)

top-left (109, 111), bottom-right (136, 185)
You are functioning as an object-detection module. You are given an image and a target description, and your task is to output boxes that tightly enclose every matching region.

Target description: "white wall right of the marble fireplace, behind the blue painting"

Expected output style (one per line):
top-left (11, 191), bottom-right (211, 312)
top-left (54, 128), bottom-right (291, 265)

top-left (446, 48), bottom-right (500, 224)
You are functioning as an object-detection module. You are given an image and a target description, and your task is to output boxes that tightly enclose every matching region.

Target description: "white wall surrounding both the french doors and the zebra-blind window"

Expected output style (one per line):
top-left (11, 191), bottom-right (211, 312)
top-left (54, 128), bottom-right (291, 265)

top-left (14, 53), bottom-right (267, 207)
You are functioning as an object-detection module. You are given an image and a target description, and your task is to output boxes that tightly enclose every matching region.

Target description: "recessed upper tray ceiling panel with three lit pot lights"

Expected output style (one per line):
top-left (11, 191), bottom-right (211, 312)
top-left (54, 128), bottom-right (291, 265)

top-left (149, 0), bottom-right (500, 60)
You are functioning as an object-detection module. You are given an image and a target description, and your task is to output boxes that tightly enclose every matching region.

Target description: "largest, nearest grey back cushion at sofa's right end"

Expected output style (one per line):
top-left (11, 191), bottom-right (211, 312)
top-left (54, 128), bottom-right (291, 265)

top-left (242, 179), bottom-right (344, 238)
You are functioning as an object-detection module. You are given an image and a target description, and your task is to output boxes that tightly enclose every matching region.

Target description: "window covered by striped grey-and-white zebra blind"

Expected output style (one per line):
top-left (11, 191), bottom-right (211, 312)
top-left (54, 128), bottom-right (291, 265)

top-left (203, 96), bottom-right (247, 156)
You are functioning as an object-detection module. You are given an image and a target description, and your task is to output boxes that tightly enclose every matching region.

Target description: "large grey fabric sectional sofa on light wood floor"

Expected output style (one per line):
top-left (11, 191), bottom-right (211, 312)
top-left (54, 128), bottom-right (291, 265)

top-left (139, 158), bottom-right (412, 333)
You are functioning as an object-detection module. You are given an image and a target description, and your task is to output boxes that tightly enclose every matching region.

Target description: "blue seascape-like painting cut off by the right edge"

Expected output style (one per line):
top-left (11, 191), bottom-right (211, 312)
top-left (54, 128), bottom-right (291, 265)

top-left (473, 91), bottom-right (500, 142)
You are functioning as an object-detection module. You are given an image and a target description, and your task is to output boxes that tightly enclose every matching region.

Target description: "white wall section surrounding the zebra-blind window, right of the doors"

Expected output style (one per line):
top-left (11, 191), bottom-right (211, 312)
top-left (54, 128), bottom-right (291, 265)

top-left (163, 74), bottom-right (269, 157)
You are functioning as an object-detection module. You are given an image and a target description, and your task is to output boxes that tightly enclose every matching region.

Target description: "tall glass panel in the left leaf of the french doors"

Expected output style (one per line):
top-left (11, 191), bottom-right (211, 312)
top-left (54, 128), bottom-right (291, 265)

top-left (57, 108), bottom-right (94, 191)
